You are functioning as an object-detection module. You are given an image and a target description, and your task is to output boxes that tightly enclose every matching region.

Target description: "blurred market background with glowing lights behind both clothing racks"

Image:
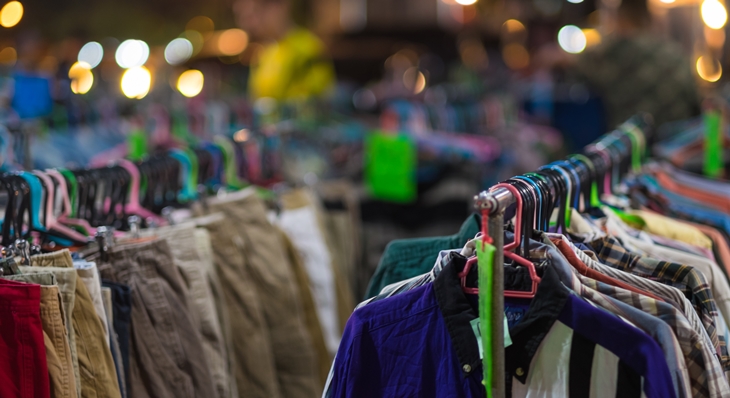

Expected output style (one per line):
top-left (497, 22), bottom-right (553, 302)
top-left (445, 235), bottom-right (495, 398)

top-left (0, 0), bottom-right (730, 291)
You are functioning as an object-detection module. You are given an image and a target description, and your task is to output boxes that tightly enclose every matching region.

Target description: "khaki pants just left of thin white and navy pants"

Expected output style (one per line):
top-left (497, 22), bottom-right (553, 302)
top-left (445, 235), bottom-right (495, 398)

top-left (31, 250), bottom-right (121, 398)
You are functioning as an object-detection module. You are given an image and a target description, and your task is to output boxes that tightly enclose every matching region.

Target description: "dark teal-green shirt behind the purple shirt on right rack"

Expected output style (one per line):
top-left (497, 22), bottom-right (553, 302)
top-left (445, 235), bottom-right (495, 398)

top-left (365, 214), bottom-right (481, 299)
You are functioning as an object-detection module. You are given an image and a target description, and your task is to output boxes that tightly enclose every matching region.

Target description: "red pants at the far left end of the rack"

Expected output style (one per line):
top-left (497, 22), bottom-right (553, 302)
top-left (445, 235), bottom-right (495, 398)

top-left (0, 279), bottom-right (51, 398)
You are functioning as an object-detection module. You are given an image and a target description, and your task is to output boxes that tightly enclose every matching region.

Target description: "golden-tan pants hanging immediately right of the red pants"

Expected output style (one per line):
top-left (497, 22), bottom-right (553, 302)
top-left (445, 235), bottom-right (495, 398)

top-left (7, 273), bottom-right (78, 398)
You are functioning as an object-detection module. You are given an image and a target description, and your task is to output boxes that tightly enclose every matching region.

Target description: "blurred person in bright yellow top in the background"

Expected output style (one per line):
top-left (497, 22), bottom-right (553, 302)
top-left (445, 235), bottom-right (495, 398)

top-left (233, 0), bottom-right (335, 101)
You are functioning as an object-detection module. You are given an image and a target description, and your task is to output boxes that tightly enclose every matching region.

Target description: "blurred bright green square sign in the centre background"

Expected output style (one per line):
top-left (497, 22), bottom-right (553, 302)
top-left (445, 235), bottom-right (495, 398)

top-left (365, 132), bottom-right (417, 203)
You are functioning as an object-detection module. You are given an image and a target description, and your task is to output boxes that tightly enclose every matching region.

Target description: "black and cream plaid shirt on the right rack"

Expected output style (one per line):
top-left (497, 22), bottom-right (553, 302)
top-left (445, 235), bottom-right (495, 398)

top-left (590, 237), bottom-right (730, 370)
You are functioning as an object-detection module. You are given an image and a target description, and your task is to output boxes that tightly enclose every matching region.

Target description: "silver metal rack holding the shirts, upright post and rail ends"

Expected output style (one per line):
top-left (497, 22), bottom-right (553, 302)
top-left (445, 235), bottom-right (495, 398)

top-left (474, 114), bottom-right (652, 397)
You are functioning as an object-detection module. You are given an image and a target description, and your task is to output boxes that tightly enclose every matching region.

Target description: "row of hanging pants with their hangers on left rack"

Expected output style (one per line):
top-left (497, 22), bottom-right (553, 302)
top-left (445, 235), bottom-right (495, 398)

top-left (0, 141), bottom-right (355, 398)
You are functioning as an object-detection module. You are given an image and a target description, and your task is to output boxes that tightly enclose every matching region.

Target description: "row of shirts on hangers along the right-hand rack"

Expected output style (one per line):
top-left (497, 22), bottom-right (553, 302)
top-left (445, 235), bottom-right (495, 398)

top-left (324, 112), bottom-right (730, 397)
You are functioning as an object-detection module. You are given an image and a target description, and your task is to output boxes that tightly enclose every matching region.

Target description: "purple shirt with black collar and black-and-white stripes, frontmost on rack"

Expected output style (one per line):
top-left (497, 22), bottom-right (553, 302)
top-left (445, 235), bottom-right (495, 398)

top-left (331, 256), bottom-right (676, 397)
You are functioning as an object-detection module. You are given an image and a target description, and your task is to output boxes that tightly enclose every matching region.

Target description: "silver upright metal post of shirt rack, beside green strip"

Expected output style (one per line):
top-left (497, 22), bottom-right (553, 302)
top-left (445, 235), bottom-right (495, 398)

top-left (489, 211), bottom-right (505, 398)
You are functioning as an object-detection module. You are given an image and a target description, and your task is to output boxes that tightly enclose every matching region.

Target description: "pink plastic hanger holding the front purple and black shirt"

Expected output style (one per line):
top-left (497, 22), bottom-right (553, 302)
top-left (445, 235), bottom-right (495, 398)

top-left (459, 183), bottom-right (540, 298)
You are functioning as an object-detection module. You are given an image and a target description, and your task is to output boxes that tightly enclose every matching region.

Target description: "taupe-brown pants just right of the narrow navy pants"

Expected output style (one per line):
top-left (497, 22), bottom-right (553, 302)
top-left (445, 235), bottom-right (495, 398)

top-left (89, 240), bottom-right (215, 398)
